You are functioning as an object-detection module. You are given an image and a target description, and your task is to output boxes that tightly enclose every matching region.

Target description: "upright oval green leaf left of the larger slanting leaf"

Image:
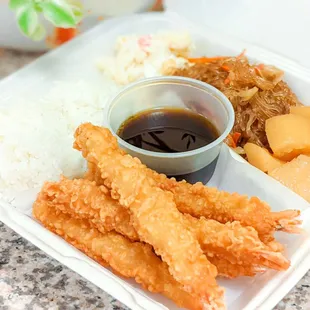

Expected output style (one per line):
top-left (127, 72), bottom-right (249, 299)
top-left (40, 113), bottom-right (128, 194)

top-left (16, 5), bottom-right (39, 37)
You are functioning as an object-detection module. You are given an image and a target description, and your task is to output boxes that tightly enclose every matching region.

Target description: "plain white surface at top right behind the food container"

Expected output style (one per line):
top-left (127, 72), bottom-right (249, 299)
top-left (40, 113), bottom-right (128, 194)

top-left (165, 0), bottom-right (310, 68)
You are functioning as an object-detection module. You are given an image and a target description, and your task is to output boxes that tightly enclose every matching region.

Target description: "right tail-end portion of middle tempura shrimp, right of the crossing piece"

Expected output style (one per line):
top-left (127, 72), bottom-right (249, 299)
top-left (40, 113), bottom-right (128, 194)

top-left (184, 214), bottom-right (290, 270)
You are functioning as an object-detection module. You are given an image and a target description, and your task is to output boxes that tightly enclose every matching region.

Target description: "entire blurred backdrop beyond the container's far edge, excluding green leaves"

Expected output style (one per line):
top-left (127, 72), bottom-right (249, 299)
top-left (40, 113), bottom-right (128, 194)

top-left (0, 0), bottom-right (310, 78)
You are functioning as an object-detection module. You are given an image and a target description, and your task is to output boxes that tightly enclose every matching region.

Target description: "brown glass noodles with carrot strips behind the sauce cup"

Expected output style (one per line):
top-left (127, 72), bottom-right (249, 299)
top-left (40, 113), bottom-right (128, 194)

top-left (174, 52), bottom-right (300, 154)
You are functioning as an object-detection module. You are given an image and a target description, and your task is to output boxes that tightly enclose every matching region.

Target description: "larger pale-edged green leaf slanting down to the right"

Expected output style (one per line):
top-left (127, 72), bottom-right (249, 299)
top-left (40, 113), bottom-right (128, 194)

top-left (40, 0), bottom-right (78, 28)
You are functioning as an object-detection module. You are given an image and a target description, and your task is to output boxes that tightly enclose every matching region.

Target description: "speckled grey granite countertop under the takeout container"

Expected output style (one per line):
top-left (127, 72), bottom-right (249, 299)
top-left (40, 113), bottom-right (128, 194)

top-left (0, 49), bottom-right (310, 310)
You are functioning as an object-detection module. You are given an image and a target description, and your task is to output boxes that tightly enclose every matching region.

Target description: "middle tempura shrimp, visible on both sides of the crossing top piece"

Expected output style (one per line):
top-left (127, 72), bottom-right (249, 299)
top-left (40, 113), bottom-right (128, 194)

top-left (40, 177), bottom-right (289, 277)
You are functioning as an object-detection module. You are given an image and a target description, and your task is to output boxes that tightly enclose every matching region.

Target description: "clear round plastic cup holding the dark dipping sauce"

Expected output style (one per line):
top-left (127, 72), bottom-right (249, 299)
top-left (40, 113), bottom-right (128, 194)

top-left (105, 76), bottom-right (235, 183)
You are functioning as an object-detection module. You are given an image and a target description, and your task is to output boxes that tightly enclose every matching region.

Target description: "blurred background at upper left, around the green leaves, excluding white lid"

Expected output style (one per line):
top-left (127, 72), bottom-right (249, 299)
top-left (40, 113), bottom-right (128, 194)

top-left (0, 0), bottom-right (163, 79)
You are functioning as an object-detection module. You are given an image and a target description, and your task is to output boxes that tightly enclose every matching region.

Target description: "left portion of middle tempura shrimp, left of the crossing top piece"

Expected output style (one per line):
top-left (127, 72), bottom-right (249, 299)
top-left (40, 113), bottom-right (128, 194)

top-left (39, 177), bottom-right (139, 241)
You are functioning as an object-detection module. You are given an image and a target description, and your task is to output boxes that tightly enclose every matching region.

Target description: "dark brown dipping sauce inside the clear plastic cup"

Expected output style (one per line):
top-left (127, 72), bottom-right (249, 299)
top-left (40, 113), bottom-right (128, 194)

top-left (117, 108), bottom-right (219, 183)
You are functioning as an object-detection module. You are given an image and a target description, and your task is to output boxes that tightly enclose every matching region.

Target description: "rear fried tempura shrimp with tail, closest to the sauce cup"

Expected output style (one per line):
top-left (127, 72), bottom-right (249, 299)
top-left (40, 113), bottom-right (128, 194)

top-left (81, 124), bottom-right (301, 243)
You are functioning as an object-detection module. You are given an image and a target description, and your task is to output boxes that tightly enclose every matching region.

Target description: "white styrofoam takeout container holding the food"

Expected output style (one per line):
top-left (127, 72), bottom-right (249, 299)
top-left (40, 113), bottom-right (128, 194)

top-left (0, 13), bottom-right (310, 310)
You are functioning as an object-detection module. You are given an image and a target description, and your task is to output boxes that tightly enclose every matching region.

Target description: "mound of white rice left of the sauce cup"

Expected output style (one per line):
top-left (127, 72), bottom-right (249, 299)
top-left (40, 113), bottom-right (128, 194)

top-left (0, 81), bottom-right (115, 202)
